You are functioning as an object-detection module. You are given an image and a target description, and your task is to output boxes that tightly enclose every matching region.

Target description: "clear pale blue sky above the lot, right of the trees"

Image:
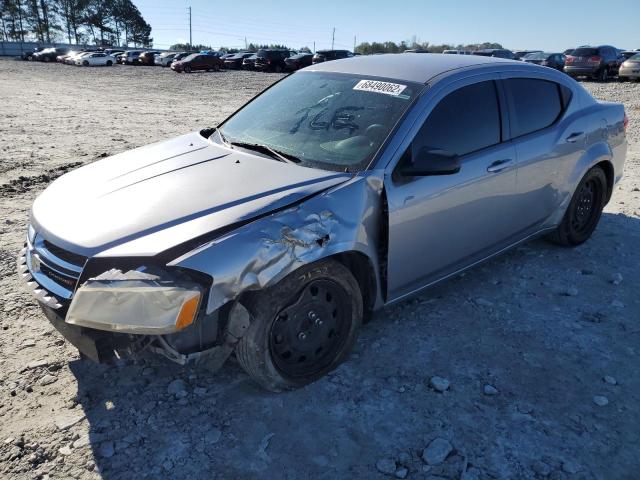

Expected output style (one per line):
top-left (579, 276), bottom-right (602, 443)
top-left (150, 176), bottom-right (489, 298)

top-left (134, 0), bottom-right (640, 51)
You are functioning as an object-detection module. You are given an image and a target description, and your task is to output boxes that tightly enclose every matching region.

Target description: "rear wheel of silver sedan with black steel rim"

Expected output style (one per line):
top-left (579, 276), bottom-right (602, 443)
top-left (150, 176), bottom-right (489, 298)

top-left (548, 167), bottom-right (608, 247)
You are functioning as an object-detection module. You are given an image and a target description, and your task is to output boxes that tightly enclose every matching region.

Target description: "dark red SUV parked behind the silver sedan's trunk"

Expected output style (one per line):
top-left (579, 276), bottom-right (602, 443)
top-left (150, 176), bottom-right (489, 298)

top-left (564, 45), bottom-right (620, 82)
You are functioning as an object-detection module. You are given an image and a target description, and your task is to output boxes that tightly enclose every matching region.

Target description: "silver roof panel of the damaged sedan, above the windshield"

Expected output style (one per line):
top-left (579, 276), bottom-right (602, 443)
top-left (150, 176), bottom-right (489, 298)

top-left (304, 53), bottom-right (522, 83)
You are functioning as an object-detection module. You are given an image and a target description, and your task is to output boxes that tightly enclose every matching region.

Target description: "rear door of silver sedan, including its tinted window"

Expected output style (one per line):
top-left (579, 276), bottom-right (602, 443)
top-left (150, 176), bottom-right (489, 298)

top-left (503, 74), bottom-right (587, 231)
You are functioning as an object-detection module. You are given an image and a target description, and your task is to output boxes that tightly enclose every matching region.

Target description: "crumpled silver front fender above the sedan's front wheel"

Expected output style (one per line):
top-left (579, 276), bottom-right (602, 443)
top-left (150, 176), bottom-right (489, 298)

top-left (169, 172), bottom-right (386, 313)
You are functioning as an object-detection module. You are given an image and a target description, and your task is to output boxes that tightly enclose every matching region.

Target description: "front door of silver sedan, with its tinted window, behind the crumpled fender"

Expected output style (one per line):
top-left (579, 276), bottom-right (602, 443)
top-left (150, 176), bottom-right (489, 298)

top-left (385, 75), bottom-right (516, 300)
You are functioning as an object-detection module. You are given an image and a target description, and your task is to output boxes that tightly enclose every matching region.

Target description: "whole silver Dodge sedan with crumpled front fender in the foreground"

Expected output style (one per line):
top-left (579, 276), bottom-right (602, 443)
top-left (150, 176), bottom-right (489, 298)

top-left (19, 54), bottom-right (627, 391)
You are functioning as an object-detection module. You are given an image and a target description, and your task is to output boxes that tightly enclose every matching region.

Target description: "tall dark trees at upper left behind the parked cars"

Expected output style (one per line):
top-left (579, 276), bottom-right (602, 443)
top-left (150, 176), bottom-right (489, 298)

top-left (0, 0), bottom-right (153, 47)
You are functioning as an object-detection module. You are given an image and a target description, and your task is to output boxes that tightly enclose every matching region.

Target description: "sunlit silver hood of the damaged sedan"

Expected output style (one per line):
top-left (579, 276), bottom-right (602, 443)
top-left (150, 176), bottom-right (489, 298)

top-left (31, 132), bottom-right (352, 256)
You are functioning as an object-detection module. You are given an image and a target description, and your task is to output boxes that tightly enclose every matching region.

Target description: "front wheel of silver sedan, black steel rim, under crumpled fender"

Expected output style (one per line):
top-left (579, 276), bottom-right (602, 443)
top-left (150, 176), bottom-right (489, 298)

top-left (236, 260), bottom-right (363, 392)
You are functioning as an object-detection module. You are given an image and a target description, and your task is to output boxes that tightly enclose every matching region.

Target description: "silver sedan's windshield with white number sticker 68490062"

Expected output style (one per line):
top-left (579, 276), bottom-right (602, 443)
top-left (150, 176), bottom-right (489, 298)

top-left (220, 72), bottom-right (423, 171)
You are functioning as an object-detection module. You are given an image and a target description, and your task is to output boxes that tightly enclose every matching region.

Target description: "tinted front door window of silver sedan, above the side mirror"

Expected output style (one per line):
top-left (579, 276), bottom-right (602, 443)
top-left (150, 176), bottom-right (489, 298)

top-left (413, 81), bottom-right (501, 155)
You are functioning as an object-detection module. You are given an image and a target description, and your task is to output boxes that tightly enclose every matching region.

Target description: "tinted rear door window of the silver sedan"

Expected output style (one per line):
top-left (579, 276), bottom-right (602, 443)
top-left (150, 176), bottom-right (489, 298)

top-left (504, 78), bottom-right (571, 138)
